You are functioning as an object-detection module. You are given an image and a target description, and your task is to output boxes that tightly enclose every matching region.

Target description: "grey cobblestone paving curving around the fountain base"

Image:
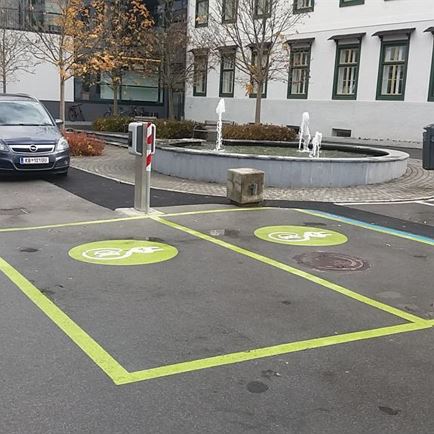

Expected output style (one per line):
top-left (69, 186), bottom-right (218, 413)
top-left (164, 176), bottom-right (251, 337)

top-left (72, 145), bottom-right (434, 202)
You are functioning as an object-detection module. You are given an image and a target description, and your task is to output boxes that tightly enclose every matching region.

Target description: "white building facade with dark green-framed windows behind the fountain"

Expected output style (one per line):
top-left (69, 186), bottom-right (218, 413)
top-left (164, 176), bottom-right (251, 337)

top-left (185, 0), bottom-right (434, 142)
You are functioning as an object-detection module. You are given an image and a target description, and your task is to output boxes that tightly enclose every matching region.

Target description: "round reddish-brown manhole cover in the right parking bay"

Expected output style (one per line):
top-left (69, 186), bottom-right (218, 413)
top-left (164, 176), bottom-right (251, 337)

top-left (294, 252), bottom-right (369, 271)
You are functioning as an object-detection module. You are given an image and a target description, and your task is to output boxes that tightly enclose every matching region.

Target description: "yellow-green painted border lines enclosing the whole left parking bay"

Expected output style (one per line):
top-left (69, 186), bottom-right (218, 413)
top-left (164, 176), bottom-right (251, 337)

top-left (0, 208), bottom-right (434, 385)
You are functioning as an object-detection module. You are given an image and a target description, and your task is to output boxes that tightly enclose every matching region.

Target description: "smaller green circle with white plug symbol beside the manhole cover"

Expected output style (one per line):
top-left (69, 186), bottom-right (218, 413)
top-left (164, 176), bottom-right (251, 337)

top-left (255, 226), bottom-right (348, 246)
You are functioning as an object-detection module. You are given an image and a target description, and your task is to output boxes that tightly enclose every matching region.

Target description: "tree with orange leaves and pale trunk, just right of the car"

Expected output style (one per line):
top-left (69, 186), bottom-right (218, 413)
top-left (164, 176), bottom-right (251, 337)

top-left (26, 0), bottom-right (102, 121)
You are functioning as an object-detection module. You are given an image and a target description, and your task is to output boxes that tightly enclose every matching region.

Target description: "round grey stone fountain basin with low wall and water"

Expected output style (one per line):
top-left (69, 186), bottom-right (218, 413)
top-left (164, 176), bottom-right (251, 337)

top-left (153, 140), bottom-right (409, 187)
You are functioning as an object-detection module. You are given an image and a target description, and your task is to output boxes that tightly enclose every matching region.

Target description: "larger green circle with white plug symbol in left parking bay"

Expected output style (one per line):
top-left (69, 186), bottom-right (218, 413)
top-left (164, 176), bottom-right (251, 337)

top-left (69, 240), bottom-right (178, 265)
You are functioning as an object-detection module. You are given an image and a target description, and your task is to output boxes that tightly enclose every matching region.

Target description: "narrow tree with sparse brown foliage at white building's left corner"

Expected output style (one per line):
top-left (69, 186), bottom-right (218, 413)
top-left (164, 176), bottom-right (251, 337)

top-left (153, 0), bottom-right (193, 119)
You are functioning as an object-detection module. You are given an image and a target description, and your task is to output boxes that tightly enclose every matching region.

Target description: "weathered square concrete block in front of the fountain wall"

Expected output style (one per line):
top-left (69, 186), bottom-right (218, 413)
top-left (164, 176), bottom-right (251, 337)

top-left (226, 168), bottom-right (265, 205)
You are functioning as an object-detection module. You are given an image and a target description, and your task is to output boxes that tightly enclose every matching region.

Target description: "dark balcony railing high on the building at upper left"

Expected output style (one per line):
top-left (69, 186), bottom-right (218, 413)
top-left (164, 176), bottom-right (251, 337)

top-left (0, 8), bottom-right (59, 33)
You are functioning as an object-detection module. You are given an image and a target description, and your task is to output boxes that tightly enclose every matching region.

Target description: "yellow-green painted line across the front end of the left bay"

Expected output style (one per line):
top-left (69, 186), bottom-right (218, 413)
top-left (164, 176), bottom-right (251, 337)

top-left (116, 323), bottom-right (431, 384)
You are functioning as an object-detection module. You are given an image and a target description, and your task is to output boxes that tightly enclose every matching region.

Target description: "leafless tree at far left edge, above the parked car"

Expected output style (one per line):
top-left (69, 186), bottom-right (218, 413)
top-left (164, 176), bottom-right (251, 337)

top-left (0, 28), bottom-right (36, 93)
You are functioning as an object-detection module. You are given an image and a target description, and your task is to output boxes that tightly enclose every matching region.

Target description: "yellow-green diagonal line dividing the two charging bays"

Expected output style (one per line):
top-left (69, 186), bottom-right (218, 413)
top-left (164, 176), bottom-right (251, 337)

top-left (151, 216), bottom-right (426, 324)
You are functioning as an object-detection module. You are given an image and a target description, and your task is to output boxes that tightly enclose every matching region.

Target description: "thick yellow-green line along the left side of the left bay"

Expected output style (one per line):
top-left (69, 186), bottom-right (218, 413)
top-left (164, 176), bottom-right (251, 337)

top-left (0, 258), bottom-right (128, 382)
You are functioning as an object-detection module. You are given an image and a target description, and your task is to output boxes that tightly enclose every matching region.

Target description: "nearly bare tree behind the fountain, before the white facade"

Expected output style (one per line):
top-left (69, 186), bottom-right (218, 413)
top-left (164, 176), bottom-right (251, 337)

top-left (193, 0), bottom-right (302, 123)
